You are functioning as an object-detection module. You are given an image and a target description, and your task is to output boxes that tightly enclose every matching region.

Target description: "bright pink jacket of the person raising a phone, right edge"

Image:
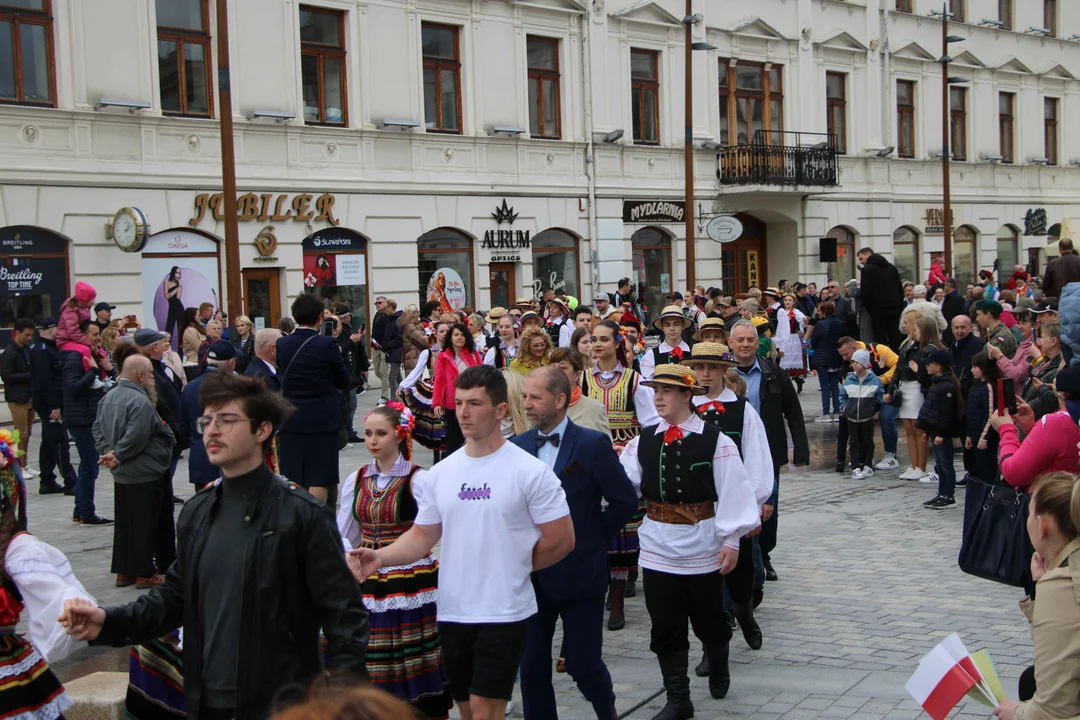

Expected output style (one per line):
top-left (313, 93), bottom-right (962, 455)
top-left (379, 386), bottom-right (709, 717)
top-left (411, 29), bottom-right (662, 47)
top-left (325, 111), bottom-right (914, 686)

top-left (998, 410), bottom-right (1080, 489)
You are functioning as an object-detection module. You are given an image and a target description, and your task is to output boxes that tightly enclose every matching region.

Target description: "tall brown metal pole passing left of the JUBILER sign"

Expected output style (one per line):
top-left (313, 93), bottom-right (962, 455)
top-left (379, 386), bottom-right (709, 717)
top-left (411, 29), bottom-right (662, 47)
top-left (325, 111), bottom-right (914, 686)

top-left (217, 0), bottom-right (243, 338)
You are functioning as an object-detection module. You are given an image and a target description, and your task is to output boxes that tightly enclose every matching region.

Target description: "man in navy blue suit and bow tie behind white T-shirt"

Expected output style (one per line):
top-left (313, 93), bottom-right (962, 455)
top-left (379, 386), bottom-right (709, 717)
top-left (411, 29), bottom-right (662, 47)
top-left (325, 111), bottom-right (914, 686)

top-left (511, 367), bottom-right (637, 720)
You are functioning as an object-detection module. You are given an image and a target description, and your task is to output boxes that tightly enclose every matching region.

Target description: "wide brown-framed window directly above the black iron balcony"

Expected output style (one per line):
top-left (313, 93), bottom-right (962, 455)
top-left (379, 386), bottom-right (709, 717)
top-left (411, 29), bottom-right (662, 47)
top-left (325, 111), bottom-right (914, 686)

top-left (720, 59), bottom-right (786, 145)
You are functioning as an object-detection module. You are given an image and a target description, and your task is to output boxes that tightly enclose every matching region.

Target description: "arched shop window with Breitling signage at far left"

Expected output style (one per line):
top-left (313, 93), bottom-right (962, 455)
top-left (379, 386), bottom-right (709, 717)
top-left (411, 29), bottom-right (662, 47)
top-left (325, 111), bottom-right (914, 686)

top-left (0, 226), bottom-right (69, 347)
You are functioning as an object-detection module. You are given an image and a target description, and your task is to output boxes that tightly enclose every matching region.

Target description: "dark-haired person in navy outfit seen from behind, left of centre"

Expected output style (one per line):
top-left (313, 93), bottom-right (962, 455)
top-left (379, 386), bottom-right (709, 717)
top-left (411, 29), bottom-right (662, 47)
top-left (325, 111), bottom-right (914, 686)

top-left (278, 293), bottom-right (349, 502)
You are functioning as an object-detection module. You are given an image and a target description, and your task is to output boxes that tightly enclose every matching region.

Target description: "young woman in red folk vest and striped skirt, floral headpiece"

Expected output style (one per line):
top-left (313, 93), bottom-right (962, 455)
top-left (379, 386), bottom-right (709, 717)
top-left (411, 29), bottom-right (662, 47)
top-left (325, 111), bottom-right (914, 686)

top-left (337, 403), bottom-right (454, 718)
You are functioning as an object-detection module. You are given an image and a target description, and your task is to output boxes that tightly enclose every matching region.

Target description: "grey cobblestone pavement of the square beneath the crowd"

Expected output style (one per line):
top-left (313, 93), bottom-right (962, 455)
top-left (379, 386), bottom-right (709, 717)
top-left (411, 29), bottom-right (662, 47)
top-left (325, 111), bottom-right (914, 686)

top-left (28, 379), bottom-right (1019, 720)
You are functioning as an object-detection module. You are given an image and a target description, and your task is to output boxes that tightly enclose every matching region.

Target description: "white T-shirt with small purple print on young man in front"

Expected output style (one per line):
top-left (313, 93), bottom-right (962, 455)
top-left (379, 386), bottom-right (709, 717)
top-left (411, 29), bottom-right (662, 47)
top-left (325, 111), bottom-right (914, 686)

top-left (413, 443), bottom-right (570, 623)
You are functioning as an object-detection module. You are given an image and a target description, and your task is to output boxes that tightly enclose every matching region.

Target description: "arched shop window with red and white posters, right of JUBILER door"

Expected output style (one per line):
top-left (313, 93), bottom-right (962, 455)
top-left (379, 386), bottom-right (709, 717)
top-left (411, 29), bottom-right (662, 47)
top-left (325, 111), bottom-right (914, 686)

top-left (303, 228), bottom-right (368, 329)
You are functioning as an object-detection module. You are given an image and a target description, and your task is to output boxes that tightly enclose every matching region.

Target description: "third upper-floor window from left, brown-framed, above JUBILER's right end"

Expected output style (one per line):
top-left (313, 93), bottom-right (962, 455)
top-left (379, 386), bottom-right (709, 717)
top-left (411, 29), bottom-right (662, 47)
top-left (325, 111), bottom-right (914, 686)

top-left (300, 5), bottom-right (349, 125)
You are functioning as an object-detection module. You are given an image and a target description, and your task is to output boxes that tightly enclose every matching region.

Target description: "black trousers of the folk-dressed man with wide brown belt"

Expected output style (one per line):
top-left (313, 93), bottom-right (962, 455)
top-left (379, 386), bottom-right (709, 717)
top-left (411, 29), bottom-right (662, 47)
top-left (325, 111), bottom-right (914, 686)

top-left (642, 568), bottom-right (731, 655)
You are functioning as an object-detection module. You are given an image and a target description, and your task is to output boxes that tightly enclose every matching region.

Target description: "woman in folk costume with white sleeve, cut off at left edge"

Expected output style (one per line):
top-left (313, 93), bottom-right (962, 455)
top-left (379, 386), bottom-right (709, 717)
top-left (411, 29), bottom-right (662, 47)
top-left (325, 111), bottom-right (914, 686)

top-left (0, 431), bottom-right (94, 720)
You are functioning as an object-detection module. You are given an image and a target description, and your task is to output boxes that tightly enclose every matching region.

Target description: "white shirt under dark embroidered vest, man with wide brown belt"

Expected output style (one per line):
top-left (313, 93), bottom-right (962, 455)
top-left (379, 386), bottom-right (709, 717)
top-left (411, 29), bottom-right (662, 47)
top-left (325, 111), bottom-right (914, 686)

top-left (622, 415), bottom-right (772, 580)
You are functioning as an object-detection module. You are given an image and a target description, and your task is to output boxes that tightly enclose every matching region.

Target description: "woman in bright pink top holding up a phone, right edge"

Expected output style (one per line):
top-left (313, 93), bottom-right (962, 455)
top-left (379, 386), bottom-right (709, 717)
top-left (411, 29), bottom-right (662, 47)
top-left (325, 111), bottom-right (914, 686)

top-left (990, 367), bottom-right (1080, 492)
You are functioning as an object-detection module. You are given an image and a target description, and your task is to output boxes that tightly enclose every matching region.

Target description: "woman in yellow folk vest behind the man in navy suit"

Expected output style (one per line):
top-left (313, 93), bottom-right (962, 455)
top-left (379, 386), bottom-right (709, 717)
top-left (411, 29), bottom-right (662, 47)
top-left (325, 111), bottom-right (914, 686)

top-left (581, 320), bottom-right (657, 630)
